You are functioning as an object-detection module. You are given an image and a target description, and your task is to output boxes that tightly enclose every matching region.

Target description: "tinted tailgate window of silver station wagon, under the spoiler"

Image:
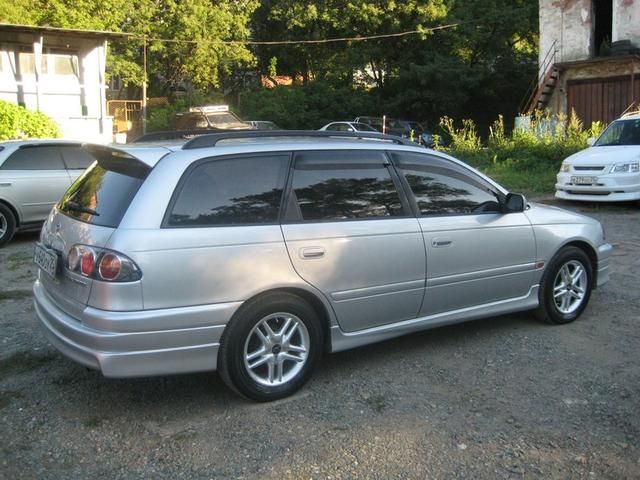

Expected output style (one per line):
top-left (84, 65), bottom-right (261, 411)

top-left (58, 147), bottom-right (151, 228)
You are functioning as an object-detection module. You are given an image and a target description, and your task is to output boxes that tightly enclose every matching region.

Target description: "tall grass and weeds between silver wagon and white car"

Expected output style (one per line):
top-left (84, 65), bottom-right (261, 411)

top-left (440, 111), bottom-right (604, 195)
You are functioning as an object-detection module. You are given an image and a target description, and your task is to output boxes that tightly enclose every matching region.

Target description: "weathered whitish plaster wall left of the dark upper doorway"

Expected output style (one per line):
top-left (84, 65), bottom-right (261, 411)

top-left (539, 0), bottom-right (592, 71)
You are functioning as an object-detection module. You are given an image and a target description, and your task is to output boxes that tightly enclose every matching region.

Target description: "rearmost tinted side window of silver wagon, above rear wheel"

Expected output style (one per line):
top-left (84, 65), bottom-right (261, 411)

top-left (165, 155), bottom-right (289, 227)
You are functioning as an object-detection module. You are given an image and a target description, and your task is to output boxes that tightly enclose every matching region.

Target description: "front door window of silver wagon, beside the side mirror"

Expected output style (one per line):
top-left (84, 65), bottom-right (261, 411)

top-left (394, 153), bottom-right (500, 216)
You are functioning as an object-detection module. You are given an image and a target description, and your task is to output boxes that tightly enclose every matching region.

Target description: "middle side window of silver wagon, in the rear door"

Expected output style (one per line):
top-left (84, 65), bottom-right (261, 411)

top-left (292, 152), bottom-right (404, 221)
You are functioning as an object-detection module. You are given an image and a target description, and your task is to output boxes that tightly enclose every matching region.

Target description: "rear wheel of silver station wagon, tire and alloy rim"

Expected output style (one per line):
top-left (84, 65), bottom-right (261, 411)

top-left (218, 292), bottom-right (323, 402)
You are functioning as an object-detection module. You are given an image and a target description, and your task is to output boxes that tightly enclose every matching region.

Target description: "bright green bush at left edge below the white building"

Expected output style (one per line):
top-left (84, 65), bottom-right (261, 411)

top-left (0, 100), bottom-right (61, 140)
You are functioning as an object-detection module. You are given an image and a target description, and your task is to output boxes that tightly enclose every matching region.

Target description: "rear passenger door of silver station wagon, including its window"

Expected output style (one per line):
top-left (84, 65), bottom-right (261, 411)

top-left (282, 150), bottom-right (425, 332)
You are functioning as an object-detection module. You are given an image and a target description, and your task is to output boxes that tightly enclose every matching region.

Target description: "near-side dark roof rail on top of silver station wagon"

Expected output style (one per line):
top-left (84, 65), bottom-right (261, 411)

top-left (182, 130), bottom-right (420, 150)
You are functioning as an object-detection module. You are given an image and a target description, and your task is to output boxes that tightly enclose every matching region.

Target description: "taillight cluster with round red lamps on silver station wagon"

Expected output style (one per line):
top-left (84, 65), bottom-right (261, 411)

top-left (67, 245), bottom-right (142, 282)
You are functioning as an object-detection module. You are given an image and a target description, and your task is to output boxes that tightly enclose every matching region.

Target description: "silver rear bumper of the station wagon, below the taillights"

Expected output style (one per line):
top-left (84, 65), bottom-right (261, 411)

top-left (33, 281), bottom-right (240, 377)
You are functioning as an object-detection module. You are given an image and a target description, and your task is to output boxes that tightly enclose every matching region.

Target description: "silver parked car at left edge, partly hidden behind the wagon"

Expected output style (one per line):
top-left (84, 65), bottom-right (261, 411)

top-left (0, 140), bottom-right (95, 247)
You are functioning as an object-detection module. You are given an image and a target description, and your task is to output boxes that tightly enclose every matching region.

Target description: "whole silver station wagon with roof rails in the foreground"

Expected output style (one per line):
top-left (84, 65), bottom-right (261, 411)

top-left (34, 131), bottom-right (611, 401)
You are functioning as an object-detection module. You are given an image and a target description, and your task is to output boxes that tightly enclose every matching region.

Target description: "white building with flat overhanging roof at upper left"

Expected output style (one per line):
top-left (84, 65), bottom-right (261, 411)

top-left (0, 24), bottom-right (126, 142)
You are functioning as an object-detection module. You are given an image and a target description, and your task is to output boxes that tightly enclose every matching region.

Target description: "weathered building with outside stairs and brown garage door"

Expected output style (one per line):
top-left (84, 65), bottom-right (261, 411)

top-left (523, 0), bottom-right (640, 126)
